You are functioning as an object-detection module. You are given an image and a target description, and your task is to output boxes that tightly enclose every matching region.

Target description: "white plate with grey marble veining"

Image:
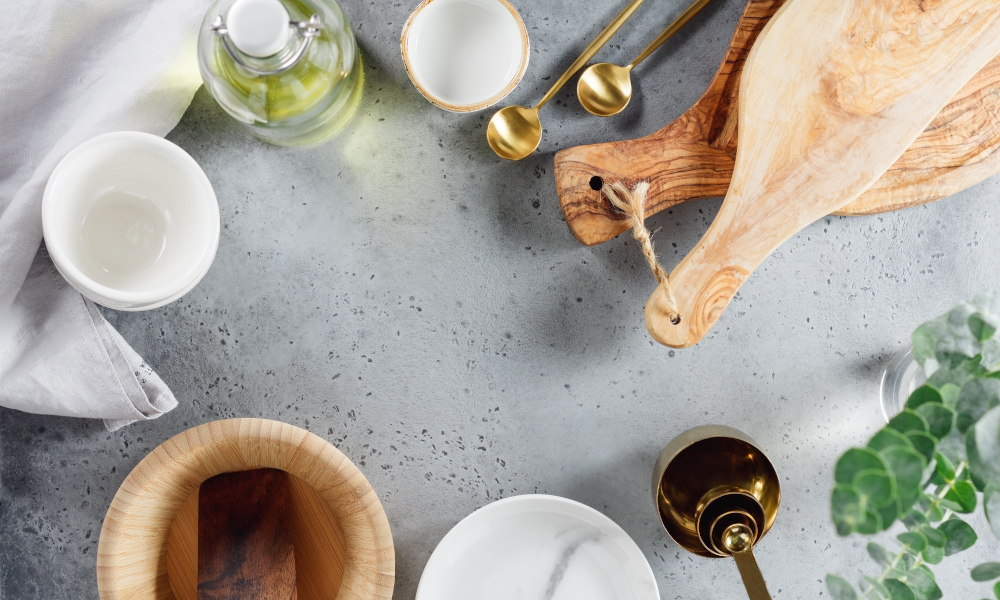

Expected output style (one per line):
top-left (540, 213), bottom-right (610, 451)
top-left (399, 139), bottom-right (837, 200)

top-left (416, 495), bottom-right (660, 600)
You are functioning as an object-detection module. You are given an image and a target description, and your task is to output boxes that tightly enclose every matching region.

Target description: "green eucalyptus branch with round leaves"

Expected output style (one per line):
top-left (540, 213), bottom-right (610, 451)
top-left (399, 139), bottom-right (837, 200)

top-left (826, 291), bottom-right (1000, 600)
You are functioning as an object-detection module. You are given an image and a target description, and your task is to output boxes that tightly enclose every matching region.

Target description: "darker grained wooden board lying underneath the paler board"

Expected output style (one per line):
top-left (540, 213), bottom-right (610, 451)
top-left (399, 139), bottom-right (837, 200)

top-left (555, 0), bottom-right (1000, 246)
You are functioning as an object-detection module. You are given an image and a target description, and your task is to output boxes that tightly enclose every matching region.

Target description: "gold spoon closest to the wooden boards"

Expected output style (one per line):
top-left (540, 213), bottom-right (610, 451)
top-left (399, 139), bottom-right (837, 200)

top-left (576, 0), bottom-right (709, 117)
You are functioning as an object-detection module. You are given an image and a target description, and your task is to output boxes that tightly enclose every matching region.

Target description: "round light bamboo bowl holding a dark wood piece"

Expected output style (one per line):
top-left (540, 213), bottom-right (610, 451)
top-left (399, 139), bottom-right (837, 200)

top-left (97, 419), bottom-right (395, 600)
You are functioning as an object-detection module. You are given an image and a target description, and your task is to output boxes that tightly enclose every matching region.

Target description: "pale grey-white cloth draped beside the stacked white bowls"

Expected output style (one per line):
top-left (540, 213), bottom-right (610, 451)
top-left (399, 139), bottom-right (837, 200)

top-left (0, 0), bottom-right (208, 429)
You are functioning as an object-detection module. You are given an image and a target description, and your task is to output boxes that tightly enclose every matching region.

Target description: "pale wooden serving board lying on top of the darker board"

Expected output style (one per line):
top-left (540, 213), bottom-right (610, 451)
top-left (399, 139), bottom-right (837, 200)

top-left (645, 0), bottom-right (1000, 347)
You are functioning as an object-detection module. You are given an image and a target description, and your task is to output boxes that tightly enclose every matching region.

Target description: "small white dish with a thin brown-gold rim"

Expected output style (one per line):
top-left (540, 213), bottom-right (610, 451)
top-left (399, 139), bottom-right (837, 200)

top-left (400, 0), bottom-right (529, 112)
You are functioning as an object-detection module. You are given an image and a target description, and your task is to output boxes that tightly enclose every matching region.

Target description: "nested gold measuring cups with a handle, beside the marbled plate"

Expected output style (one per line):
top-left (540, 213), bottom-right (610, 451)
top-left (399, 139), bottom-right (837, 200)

top-left (652, 425), bottom-right (781, 600)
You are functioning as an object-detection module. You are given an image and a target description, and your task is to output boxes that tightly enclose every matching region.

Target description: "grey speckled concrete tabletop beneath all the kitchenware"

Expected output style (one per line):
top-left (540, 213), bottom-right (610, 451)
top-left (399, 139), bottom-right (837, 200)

top-left (0, 0), bottom-right (1000, 600)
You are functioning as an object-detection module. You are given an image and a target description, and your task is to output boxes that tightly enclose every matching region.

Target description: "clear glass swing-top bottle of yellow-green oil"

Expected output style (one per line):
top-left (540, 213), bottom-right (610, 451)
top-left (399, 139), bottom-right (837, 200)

top-left (198, 0), bottom-right (364, 146)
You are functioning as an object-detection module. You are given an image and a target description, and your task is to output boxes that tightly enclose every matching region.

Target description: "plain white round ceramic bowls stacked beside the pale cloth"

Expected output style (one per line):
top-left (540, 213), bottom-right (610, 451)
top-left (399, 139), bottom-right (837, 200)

top-left (42, 131), bottom-right (219, 310)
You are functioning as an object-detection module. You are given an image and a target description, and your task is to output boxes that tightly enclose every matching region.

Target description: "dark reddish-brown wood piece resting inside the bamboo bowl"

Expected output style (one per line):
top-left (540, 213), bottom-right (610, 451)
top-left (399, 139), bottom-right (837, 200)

top-left (196, 469), bottom-right (298, 600)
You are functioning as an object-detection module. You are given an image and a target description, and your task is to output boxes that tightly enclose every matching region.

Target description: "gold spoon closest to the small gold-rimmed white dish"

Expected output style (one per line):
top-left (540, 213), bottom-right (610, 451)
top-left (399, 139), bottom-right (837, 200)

top-left (486, 0), bottom-right (644, 160)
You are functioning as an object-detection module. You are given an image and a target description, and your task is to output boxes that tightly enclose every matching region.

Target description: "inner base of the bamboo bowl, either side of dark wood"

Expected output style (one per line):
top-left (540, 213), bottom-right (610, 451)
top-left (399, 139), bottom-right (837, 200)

top-left (163, 473), bottom-right (347, 600)
